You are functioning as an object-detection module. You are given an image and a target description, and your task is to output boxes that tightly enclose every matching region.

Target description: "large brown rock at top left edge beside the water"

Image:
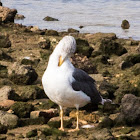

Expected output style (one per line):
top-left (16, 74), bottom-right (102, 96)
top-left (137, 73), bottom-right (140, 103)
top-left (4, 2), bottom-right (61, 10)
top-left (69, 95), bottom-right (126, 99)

top-left (0, 6), bottom-right (17, 23)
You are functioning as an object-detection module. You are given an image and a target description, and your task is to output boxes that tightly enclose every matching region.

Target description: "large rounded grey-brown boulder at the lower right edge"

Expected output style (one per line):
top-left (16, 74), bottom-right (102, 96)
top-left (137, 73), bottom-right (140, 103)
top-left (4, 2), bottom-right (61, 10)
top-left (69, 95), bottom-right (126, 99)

top-left (115, 94), bottom-right (140, 126)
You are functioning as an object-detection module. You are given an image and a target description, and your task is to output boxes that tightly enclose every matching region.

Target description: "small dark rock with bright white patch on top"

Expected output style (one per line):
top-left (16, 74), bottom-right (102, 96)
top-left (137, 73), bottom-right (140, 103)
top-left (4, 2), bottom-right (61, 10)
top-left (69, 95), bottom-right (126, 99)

top-left (21, 57), bottom-right (40, 66)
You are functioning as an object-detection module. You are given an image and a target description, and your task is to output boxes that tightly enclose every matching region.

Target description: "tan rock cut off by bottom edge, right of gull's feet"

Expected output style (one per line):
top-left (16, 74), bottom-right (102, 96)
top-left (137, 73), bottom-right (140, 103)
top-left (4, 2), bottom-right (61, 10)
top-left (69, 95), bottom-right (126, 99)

top-left (93, 128), bottom-right (115, 140)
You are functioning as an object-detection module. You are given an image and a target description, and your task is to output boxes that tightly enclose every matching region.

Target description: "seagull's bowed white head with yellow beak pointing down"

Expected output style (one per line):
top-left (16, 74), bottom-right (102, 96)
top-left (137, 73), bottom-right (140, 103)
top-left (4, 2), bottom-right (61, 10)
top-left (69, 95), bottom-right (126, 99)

top-left (55, 36), bottom-right (76, 66)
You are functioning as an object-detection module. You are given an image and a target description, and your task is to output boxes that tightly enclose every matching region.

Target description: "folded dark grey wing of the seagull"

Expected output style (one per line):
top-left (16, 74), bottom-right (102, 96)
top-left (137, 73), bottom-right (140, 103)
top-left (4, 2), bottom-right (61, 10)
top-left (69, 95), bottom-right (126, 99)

top-left (72, 68), bottom-right (102, 104)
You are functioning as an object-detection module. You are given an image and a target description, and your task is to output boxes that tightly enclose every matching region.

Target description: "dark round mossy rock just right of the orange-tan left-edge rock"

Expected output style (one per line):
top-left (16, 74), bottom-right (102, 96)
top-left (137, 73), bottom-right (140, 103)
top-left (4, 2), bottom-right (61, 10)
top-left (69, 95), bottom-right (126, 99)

top-left (10, 102), bottom-right (33, 118)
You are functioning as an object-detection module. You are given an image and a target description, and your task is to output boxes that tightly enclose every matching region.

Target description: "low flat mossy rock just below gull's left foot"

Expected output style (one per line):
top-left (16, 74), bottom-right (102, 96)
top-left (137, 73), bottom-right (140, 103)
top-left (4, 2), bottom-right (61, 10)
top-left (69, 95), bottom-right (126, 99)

top-left (41, 128), bottom-right (66, 137)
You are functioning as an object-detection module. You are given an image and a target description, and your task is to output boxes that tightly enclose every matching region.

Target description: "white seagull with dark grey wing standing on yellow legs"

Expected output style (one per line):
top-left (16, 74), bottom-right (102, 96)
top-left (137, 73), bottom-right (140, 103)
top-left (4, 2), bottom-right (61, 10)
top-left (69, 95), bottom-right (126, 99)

top-left (42, 35), bottom-right (106, 131)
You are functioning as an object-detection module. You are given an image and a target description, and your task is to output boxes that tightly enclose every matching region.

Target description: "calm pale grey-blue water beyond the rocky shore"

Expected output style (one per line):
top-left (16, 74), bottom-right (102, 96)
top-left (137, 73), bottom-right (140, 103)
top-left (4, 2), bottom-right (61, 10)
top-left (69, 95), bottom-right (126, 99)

top-left (1, 0), bottom-right (140, 40)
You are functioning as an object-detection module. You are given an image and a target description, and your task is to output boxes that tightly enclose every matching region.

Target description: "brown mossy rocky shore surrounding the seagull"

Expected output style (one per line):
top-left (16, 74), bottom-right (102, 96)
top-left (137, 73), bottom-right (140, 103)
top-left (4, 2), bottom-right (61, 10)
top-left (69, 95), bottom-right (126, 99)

top-left (0, 3), bottom-right (140, 140)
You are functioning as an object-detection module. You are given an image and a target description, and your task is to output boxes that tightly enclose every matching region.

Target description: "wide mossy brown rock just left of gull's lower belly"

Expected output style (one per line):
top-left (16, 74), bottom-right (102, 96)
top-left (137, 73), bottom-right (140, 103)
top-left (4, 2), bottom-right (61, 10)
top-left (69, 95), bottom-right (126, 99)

top-left (17, 85), bottom-right (47, 101)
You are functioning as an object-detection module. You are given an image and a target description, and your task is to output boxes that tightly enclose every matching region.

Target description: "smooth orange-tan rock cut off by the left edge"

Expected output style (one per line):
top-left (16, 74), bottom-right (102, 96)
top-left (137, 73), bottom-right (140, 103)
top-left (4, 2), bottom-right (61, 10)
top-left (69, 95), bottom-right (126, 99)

top-left (0, 100), bottom-right (15, 110)
